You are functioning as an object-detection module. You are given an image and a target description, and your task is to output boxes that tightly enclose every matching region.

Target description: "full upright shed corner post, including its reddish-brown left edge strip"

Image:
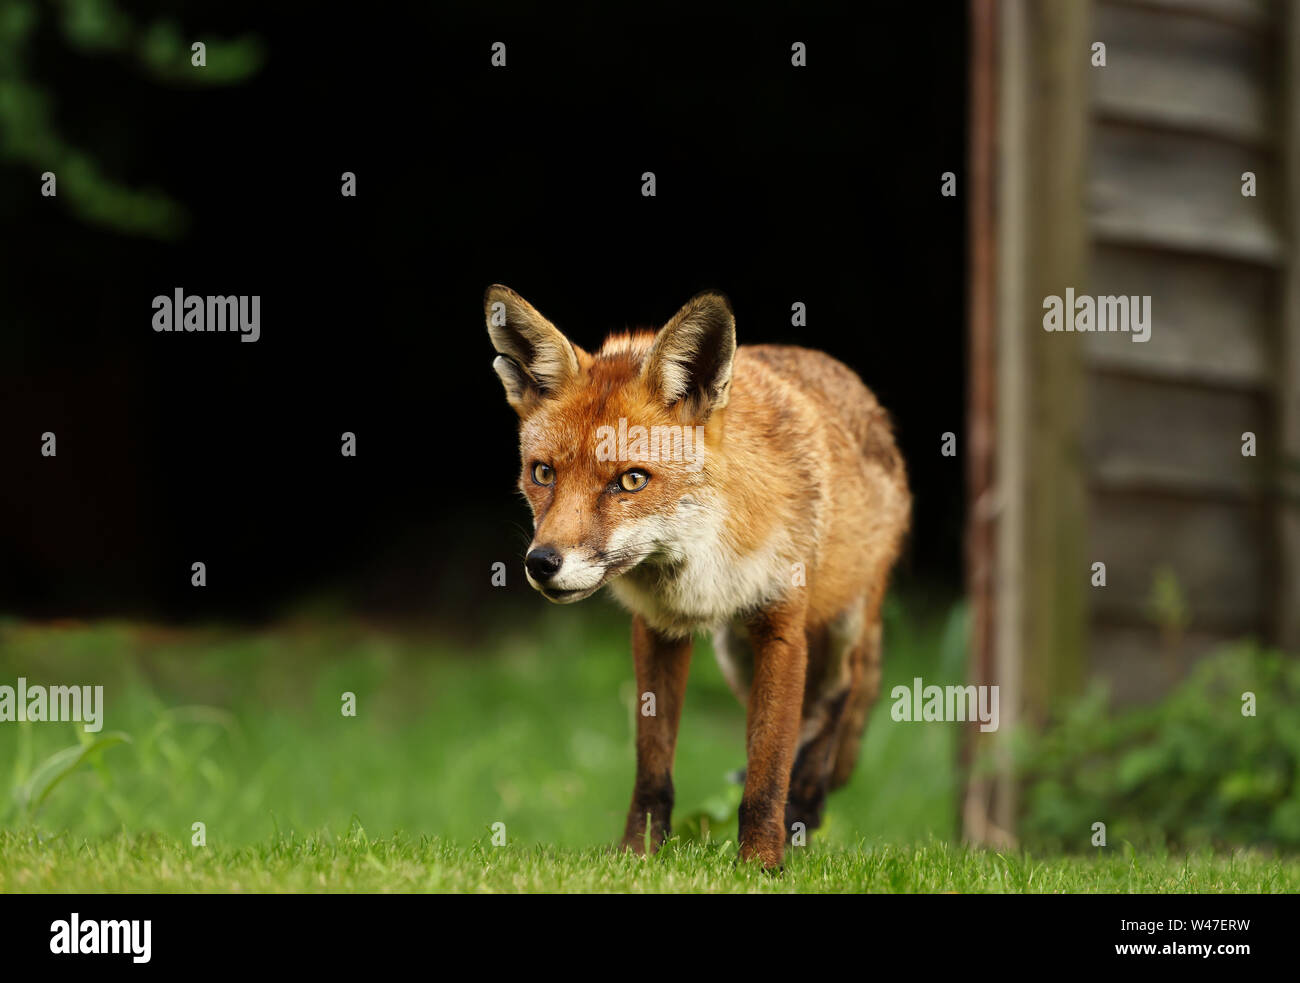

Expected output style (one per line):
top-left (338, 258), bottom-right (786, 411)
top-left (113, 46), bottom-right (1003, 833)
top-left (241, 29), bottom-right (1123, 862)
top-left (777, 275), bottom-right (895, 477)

top-left (963, 0), bottom-right (1089, 845)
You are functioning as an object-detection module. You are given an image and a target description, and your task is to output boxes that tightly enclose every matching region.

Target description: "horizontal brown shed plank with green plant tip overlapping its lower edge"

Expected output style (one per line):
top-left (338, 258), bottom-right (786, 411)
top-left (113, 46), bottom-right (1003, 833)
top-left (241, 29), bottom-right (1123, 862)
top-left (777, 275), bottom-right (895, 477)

top-left (1080, 492), bottom-right (1273, 632)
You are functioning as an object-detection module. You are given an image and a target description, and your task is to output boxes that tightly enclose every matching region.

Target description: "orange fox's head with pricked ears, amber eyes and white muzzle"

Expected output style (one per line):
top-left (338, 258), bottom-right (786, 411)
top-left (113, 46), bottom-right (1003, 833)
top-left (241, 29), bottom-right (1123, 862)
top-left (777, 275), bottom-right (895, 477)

top-left (484, 285), bottom-right (736, 603)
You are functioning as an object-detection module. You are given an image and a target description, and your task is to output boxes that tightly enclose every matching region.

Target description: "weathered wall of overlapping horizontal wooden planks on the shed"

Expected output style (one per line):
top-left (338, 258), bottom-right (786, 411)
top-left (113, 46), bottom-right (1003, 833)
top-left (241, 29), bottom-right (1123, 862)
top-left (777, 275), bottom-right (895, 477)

top-left (1082, 0), bottom-right (1287, 701)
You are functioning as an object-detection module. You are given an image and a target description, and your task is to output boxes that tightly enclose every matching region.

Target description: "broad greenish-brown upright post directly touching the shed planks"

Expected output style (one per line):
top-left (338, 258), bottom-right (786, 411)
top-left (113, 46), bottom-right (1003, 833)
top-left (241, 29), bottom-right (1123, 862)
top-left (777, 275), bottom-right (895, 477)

top-left (1021, 0), bottom-right (1105, 724)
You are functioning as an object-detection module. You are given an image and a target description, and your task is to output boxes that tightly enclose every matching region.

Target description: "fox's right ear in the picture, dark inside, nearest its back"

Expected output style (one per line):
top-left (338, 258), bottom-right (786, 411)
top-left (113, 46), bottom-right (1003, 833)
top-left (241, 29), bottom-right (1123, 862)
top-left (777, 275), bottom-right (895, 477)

top-left (644, 293), bottom-right (736, 420)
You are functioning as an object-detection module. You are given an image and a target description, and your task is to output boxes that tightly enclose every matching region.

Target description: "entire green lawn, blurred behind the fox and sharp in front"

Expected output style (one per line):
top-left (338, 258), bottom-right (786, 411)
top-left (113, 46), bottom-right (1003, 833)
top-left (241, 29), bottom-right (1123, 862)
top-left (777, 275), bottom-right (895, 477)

top-left (0, 603), bottom-right (1300, 892)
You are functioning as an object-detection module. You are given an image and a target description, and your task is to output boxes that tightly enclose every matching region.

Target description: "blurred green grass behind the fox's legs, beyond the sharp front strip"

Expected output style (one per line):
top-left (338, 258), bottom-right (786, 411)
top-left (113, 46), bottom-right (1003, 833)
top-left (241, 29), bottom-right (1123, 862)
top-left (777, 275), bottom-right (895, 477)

top-left (0, 595), bottom-right (961, 848)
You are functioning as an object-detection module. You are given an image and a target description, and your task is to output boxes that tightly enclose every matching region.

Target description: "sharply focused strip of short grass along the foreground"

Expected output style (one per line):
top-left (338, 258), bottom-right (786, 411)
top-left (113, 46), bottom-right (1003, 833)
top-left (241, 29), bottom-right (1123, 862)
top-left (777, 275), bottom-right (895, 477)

top-left (0, 828), bottom-right (1300, 893)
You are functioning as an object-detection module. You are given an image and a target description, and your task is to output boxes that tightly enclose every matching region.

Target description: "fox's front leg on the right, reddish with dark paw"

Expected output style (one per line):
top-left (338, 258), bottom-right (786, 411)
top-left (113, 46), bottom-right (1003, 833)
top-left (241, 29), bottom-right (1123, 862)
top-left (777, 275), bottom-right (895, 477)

top-left (740, 605), bottom-right (807, 867)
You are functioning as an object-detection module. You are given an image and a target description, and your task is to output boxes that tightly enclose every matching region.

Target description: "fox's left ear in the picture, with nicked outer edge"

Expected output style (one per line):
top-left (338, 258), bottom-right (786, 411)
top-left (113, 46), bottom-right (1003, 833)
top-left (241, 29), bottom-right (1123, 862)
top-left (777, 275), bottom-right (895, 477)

top-left (484, 283), bottom-right (579, 416)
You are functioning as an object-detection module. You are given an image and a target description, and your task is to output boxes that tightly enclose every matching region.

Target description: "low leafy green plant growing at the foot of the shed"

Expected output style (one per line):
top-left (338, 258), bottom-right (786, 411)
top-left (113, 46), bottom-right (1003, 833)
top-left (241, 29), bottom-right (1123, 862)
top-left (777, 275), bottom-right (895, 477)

top-left (1018, 644), bottom-right (1300, 849)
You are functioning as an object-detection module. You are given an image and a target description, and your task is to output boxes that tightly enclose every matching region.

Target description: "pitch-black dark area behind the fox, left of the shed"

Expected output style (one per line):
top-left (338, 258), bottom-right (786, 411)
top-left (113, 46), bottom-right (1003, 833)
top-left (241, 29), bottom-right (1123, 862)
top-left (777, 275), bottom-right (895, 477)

top-left (0, 4), bottom-right (966, 620)
